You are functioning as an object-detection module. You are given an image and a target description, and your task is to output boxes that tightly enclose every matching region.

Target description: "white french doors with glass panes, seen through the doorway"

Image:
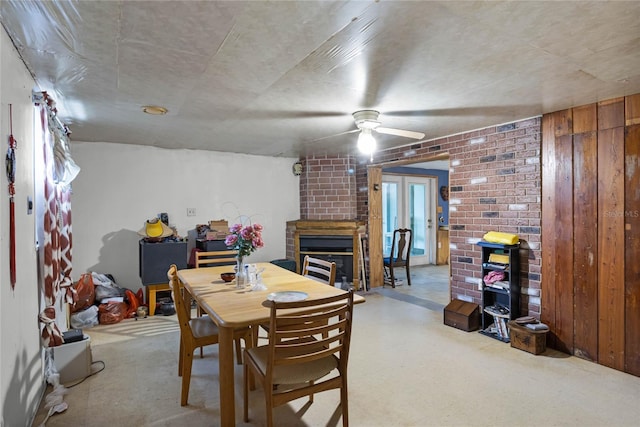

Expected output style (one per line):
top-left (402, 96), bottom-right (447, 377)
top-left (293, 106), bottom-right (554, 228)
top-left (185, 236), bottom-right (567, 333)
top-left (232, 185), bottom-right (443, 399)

top-left (382, 174), bottom-right (437, 265)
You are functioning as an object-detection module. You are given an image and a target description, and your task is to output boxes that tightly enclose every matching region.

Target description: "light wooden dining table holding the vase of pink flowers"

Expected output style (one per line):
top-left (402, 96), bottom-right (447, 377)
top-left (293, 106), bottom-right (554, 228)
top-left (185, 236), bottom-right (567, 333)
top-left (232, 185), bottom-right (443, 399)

top-left (178, 263), bottom-right (365, 426)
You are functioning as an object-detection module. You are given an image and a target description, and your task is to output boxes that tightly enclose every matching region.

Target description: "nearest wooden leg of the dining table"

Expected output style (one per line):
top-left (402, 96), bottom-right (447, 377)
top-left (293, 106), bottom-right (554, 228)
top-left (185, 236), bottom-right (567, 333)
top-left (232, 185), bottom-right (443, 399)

top-left (218, 327), bottom-right (236, 427)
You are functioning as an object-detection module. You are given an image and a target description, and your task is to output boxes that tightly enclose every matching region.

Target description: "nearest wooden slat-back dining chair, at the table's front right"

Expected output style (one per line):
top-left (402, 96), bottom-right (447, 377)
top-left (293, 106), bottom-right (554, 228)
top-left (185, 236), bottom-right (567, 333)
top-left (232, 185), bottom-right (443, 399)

top-left (244, 291), bottom-right (353, 427)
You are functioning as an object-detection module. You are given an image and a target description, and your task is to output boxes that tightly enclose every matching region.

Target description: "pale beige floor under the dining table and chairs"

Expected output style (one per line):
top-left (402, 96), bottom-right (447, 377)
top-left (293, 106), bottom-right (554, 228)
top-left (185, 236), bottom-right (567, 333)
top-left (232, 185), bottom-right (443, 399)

top-left (34, 266), bottom-right (640, 427)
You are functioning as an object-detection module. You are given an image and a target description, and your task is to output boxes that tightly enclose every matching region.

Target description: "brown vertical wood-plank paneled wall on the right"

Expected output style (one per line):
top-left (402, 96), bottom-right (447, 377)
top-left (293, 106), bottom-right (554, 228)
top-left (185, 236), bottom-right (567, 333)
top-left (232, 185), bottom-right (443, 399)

top-left (541, 95), bottom-right (640, 375)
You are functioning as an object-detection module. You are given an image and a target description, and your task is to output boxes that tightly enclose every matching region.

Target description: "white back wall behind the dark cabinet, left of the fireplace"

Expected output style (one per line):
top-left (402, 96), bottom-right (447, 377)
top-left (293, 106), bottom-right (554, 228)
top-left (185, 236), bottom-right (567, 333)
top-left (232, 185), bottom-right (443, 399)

top-left (71, 142), bottom-right (300, 292)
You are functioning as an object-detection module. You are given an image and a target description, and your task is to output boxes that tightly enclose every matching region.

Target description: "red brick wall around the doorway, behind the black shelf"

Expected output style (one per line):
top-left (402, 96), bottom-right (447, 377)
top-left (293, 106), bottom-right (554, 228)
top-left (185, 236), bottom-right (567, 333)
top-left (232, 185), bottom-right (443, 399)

top-left (354, 118), bottom-right (541, 315)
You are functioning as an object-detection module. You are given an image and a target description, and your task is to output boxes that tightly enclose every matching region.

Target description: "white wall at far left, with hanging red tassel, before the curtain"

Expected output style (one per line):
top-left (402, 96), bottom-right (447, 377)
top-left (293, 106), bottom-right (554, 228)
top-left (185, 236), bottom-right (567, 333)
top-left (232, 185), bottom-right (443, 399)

top-left (0, 31), bottom-right (44, 426)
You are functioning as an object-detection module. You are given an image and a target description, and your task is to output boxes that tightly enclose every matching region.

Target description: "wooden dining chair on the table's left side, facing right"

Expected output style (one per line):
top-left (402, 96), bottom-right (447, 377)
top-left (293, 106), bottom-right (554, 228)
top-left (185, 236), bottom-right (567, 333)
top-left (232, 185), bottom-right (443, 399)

top-left (167, 264), bottom-right (252, 406)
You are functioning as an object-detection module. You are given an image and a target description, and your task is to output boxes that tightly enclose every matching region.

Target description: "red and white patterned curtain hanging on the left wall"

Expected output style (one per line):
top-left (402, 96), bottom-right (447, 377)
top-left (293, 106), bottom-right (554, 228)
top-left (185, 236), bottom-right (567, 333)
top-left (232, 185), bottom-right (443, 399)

top-left (34, 92), bottom-right (79, 347)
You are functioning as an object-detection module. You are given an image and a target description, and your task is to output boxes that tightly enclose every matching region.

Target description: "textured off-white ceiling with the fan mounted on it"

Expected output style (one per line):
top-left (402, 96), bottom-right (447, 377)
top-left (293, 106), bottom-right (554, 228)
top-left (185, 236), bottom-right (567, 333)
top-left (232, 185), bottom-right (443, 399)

top-left (0, 1), bottom-right (640, 157)
